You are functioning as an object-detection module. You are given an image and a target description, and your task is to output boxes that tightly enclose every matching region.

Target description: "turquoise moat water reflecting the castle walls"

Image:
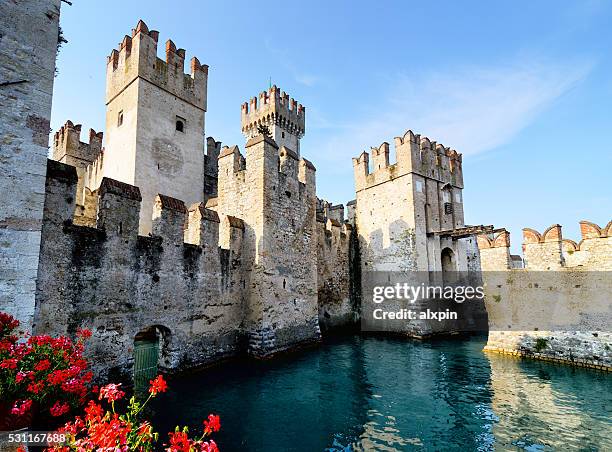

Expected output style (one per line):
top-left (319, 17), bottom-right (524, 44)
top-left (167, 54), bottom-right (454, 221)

top-left (155, 337), bottom-right (612, 452)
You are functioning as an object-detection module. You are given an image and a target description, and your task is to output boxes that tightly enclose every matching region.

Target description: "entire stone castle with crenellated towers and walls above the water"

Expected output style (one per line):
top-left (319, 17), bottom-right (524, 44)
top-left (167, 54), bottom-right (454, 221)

top-left (0, 8), bottom-right (610, 380)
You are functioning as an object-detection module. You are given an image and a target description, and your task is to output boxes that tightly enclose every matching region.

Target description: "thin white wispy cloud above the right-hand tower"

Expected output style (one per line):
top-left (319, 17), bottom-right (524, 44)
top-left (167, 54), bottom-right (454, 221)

top-left (310, 56), bottom-right (593, 166)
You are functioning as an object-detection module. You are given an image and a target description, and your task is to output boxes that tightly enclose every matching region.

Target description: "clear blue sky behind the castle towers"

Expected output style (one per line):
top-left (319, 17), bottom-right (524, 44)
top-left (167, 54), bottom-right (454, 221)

top-left (52, 0), bottom-right (612, 251)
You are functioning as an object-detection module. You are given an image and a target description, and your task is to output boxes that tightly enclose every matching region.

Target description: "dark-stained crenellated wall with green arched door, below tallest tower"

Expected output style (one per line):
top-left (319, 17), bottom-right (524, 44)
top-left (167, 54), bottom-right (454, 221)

top-left (34, 160), bottom-right (244, 380)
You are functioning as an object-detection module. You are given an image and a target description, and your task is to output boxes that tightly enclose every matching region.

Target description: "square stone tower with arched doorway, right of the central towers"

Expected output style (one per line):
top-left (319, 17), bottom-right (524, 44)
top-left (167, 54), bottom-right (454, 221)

top-left (353, 130), bottom-right (486, 336)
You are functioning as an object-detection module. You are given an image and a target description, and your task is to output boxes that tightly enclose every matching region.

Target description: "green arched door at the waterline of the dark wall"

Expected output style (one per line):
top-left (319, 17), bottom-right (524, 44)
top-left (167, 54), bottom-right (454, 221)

top-left (134, 325), bottom-right (170, 391)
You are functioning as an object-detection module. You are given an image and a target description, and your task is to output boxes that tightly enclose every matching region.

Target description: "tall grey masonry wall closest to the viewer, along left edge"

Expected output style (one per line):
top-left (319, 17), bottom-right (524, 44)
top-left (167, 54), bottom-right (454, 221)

top-left (0, 0), bottom-right (60, 330)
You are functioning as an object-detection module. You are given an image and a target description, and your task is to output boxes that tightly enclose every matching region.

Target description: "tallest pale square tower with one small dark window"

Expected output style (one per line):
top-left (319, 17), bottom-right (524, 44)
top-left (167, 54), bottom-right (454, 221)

top-left (103, 20), bottom-right (208, 234)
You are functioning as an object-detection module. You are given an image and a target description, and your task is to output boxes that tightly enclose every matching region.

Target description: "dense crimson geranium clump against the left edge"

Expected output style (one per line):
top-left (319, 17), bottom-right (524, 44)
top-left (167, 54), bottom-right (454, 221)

top-left (0, 313), bottom-right (92, 428)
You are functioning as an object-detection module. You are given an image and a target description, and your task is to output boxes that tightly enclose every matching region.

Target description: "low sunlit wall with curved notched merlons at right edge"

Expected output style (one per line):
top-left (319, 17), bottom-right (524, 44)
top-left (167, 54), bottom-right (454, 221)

top-left (478, 221), bottom-right (612, 370)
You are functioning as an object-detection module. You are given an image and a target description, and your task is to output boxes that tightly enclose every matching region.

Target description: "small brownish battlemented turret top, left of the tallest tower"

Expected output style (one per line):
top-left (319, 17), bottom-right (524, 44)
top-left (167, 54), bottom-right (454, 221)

top-left (53, 120), bottom-right (104, 166)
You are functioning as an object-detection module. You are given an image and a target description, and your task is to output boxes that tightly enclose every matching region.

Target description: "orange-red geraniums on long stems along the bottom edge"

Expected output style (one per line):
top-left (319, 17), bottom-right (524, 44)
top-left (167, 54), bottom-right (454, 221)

top-left (48, 375), bottom-right (221, 452)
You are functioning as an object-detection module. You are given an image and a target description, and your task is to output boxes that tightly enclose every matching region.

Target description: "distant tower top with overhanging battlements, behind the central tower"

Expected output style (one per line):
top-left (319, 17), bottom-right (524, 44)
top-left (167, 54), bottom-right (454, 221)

top-left (241, 85), bottom-right (306, 157)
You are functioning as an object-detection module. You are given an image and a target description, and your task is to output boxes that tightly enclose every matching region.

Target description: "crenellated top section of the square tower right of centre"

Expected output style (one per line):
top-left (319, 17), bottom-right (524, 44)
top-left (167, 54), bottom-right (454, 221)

top-left (353, 130), bottom-right (463, 191)
